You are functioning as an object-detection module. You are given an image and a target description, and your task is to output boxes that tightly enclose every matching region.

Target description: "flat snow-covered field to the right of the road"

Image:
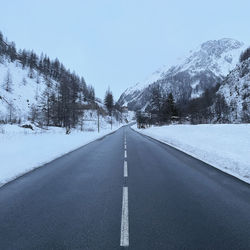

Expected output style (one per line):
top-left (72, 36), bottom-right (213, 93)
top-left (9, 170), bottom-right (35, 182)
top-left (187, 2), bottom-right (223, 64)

top-left (133, 124), bottom-right (250, 183)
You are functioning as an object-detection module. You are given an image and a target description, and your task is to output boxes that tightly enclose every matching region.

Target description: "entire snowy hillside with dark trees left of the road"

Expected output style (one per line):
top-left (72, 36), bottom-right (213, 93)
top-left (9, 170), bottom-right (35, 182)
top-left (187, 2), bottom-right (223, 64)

top-left (0, 33), bottom-right (127, 128)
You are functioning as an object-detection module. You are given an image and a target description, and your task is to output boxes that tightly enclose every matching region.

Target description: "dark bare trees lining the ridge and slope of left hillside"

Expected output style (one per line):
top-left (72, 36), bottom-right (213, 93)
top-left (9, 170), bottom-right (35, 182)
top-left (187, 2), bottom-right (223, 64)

top-left (0, 32), bottom-right (96, 127)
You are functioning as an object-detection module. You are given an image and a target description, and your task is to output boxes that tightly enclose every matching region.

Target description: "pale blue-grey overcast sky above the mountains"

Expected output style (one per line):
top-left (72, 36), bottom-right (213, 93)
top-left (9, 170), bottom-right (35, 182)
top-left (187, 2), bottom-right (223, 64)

top-left (0, 0), bottom-right (250, 99)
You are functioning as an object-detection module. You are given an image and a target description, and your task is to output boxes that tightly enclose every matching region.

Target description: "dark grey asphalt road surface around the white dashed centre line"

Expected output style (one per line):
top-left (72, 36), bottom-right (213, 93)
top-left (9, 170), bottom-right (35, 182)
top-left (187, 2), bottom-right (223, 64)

top-left (0, 127), bottom-right (250, 250)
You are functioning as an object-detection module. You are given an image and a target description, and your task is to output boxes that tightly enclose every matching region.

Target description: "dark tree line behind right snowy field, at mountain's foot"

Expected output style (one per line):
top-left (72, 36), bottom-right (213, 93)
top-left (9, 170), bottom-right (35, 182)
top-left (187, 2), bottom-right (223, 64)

top-left (136, 84), bottom-right (229, 127)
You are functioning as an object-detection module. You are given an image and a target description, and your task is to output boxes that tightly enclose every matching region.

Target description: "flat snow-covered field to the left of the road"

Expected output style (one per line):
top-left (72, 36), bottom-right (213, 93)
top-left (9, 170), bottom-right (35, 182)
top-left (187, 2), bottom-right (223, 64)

top-left (0, 124), bottom-right (119, 186)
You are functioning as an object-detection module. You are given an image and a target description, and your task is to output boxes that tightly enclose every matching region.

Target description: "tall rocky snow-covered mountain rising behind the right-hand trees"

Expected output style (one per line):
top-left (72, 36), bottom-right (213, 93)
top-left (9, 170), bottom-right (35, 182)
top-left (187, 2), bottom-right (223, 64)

top-left (118, 38), bottom-right (245, 110)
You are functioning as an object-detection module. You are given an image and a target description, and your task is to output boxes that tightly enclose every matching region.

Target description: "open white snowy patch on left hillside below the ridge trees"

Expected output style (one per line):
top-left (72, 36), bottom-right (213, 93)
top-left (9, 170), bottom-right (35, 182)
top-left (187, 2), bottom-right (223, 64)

top-left (0, 60), bottom-right (49, 121)
